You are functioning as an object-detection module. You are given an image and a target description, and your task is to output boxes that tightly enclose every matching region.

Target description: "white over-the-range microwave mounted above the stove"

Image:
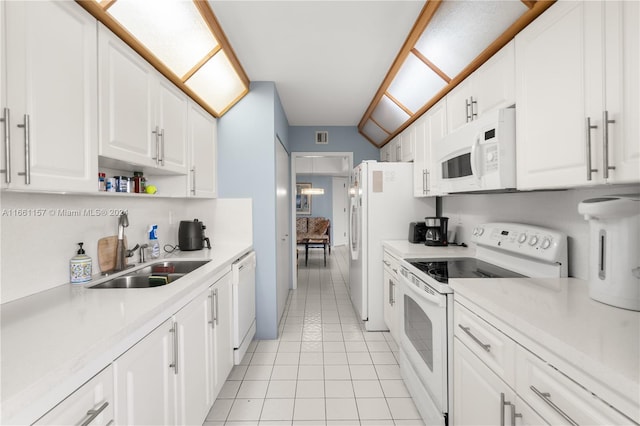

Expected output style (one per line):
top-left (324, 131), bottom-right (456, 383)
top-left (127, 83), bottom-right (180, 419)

top-left (435, 108), bottom-right (516, 193)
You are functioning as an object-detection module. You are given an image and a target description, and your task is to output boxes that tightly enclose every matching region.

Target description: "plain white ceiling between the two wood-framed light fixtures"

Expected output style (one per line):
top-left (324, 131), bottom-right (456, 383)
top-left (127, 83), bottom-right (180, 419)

top-left (209, 0), bottom-right (425, 126)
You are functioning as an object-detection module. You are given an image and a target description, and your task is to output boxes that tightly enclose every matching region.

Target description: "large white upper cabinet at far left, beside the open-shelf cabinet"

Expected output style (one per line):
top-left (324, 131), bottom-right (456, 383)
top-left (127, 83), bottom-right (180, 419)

top-left (0, 1), bottom-right (98, 192)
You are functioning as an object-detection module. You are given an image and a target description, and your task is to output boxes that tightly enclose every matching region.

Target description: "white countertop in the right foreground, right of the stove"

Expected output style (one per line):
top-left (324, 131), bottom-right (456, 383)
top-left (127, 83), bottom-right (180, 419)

top-left (449, 278), bottom-right (640, 422)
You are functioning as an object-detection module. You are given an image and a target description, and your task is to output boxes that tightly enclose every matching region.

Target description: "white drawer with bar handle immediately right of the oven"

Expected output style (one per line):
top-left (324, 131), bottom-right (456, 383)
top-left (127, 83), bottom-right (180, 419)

top-left (453, 303), bottom-right (516, 386)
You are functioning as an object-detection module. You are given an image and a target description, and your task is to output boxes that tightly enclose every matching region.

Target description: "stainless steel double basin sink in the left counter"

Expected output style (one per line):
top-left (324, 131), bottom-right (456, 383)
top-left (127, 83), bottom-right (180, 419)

top-left (89, 260), bottom-right (209, 288)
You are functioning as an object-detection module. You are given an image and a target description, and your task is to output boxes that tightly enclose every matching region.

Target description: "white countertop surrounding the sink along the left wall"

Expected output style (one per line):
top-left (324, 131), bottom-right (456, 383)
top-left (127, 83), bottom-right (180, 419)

top-left (0, 244), bottom-right (252, 424)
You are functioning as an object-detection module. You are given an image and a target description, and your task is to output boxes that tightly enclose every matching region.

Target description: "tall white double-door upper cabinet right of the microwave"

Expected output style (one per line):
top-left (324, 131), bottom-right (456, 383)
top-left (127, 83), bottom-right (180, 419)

top-left (516, 1), bottom-right (640, 189)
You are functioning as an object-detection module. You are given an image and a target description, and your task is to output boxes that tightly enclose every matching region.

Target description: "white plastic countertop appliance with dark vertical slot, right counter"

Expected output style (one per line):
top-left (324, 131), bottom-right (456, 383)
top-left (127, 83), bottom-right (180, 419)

top-left (578, 194), bottom-right (640, 311)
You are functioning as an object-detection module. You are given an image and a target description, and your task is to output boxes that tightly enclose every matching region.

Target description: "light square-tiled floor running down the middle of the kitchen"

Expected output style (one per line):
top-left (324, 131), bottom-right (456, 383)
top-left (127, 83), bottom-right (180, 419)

top-left (204, 247), bottom-right (424, 426)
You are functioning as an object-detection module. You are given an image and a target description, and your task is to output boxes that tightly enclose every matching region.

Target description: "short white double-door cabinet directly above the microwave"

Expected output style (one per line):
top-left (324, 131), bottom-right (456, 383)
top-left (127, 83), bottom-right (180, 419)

top-left (447, 41), bottom-right (515, 132)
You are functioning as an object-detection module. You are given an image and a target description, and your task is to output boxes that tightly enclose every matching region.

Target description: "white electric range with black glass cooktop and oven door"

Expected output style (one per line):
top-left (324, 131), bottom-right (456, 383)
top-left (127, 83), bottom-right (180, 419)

top-left (399, 223), bottom-right (567, 425)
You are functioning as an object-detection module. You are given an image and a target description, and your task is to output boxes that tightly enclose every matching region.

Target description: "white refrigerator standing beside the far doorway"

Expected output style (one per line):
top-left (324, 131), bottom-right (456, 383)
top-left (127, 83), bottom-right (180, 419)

top-left (349, 161), bottom-right (435, 331)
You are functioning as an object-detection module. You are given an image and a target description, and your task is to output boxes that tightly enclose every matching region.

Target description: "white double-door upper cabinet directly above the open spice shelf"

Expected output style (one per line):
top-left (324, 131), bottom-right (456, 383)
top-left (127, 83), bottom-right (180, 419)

top-left (98, 25), bottom-right (188, 174)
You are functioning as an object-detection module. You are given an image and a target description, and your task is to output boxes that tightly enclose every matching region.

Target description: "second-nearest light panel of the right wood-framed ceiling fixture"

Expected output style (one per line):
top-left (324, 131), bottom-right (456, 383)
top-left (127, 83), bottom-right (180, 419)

top-left (387, 53), bottom-right (447, 115)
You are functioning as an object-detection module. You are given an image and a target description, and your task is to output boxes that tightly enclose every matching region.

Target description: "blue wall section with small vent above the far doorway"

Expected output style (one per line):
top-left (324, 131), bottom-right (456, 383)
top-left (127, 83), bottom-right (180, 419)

top-left (289, 126), bottom-right (380, 166)
